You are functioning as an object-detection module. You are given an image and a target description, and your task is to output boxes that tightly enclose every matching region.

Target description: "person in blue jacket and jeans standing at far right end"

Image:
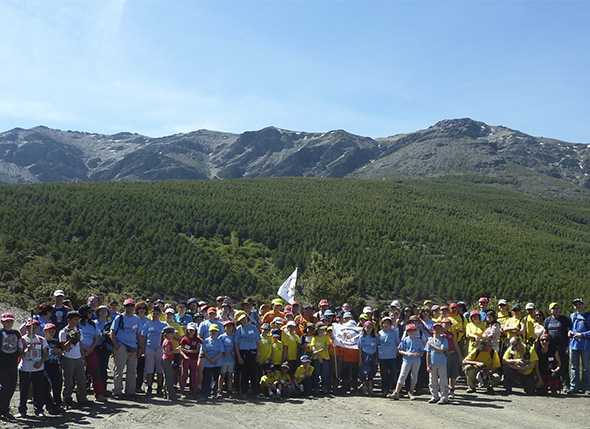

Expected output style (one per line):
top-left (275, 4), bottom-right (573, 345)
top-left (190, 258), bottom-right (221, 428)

top-left (568, 298), bottom-right (590, 393)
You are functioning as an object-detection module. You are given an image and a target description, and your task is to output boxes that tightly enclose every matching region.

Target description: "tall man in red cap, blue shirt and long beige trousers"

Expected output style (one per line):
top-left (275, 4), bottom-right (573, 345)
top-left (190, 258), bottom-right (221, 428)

top-left (111, 298), bottom-right (141, 399)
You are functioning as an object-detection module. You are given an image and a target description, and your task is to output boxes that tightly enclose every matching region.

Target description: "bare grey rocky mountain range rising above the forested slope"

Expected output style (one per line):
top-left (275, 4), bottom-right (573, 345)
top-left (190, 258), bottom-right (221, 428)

top-left (0, 118), bottom-right (590, 193)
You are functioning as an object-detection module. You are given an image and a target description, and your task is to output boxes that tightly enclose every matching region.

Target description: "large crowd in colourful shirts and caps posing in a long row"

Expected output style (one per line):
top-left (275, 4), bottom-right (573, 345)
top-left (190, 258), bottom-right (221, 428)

top-left (0, 290), bottom-right (590, 420)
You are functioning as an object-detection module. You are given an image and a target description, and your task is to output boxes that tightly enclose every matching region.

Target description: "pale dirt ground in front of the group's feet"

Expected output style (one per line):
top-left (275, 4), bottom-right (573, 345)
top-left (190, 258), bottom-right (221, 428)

top-left (0, 391), bottom-right (590, 429)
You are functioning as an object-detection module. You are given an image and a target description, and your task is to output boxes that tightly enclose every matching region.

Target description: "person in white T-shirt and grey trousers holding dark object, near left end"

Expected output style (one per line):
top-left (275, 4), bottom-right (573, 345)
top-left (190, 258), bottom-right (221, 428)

top-left (58, 311), bottom-right (88, 407)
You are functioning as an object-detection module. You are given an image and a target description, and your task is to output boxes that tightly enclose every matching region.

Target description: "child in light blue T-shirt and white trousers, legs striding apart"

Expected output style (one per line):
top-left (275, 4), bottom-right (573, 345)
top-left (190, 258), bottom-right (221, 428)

top-left (387, 323), bottom-right (424, 401)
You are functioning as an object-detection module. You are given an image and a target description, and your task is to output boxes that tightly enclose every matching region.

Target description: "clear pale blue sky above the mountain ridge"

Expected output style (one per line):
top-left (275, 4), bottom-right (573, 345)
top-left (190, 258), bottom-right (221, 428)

top-left (0, 0), bottom-right (590, 143)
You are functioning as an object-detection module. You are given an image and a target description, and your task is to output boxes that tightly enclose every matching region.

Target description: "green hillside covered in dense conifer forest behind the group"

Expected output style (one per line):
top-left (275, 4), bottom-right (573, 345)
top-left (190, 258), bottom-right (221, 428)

top-left (0, 178), bottom-right (590, 303)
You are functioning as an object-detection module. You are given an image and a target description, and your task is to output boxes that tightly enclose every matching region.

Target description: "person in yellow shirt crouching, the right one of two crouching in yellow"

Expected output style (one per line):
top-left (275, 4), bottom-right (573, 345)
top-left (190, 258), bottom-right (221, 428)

top-left (503, 337), bottom-right (539, 395)
